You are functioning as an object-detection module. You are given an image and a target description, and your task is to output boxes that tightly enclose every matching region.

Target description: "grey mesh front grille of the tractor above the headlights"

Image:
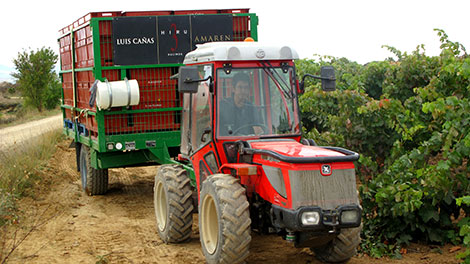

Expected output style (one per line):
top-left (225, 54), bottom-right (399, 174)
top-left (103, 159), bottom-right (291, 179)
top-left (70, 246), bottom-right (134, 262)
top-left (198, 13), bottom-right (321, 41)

top-left (289, 169), bottom-right (358, 210)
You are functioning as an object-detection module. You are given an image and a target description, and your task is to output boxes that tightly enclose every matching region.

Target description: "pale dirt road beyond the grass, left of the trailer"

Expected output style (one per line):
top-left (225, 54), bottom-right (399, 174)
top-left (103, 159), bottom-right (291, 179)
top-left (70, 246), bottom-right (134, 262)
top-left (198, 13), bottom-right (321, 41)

top-left (0, 114), bottom-right (62, 149)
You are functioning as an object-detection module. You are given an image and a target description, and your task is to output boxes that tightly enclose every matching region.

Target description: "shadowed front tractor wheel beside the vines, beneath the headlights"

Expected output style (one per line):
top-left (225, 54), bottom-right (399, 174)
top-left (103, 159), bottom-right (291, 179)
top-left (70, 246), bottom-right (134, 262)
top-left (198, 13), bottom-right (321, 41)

top-left (312, 225), bottom-right (362, 262)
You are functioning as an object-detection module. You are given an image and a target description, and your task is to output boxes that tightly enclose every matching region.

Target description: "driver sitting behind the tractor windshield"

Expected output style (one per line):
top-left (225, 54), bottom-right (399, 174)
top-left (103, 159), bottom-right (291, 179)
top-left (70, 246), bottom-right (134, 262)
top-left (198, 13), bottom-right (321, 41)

top-left (219, 73), bottom-right (263, 136)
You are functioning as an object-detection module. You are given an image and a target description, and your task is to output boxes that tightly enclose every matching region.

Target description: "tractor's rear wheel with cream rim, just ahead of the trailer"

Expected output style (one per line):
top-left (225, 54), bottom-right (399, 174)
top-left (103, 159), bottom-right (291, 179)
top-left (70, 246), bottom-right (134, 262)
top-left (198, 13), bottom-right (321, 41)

top-left (153, 164), bottom-right (194, 243)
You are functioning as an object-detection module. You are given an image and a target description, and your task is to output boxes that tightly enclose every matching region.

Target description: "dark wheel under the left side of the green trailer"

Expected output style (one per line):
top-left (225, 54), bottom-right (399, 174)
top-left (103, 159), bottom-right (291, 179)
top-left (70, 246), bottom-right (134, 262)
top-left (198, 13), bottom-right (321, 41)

top-left (80, 144), bottom-right (108, 195)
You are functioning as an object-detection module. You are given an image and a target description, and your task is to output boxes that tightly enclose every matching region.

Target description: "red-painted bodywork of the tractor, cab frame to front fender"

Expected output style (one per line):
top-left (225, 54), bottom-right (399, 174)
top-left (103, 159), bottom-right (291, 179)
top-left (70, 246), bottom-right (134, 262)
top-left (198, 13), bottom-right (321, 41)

top-left (183, 61), bottom-right (354, 209)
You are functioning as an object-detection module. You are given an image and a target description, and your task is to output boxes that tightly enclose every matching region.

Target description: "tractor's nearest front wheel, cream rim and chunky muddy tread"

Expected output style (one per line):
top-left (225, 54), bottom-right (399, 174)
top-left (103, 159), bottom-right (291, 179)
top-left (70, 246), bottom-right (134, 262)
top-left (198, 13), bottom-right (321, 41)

top-left (199, 174), bottom-right (251, 263)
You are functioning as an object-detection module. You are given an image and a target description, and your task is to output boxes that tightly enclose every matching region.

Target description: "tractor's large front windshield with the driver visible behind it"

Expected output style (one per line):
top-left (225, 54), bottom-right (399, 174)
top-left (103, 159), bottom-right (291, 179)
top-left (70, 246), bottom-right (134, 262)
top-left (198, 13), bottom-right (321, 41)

top-left (217, 64), bottom-right (300, 137)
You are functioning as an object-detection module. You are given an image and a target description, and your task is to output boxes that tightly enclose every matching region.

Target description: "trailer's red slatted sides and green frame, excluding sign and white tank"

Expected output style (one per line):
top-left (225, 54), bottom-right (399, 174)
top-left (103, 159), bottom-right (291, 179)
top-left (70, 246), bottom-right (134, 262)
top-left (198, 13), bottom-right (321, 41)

top-left (59, 9), bottom-right (258, 173)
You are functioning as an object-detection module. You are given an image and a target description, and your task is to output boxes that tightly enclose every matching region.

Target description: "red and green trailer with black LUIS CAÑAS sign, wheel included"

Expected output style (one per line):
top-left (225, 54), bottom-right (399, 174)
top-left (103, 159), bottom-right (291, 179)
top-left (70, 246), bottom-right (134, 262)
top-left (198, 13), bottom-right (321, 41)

top-left (58, 9), bottom-right (258, 195)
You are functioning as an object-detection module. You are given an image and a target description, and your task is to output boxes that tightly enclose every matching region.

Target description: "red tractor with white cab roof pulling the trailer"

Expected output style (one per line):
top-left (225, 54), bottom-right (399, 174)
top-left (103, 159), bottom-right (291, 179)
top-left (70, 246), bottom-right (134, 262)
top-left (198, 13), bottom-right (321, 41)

top-left (154, 42), bottom-right (362, 263)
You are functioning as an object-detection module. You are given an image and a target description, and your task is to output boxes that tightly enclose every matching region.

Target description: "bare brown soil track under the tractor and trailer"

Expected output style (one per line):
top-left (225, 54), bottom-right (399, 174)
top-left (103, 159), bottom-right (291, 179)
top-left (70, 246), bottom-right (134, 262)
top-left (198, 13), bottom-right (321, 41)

top-left (4, 140), bottom-right (462, 264)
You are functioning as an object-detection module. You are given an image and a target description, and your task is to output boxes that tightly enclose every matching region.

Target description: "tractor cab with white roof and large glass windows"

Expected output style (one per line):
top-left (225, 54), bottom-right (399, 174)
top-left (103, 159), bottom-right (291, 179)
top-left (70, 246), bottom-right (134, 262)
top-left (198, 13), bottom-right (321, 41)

top-left (179, 42), bottom-right (301, 151)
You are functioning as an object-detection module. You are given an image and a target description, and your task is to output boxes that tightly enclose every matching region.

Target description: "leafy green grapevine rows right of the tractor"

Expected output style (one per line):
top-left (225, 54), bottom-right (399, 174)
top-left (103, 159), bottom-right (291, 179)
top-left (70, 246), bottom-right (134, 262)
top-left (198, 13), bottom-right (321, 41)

top-left (297, 29), bottom-right (470, 262)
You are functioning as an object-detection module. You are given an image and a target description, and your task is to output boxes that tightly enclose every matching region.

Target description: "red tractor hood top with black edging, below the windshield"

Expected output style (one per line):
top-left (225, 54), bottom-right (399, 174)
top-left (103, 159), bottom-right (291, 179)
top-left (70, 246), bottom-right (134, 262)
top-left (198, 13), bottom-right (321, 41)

top-left (243, 139), bottom-right (359, 163)
